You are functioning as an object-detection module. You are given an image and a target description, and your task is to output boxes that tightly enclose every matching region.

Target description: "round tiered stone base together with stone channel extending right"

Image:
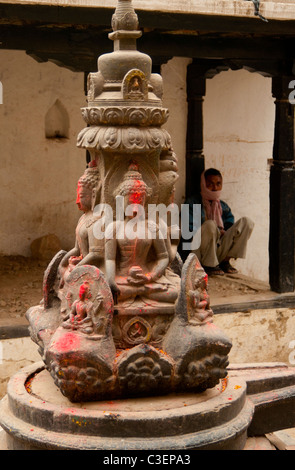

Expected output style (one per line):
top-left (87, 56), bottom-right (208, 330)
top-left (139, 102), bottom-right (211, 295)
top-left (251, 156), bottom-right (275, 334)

top-left (0, 362), bottom-right (295, 451)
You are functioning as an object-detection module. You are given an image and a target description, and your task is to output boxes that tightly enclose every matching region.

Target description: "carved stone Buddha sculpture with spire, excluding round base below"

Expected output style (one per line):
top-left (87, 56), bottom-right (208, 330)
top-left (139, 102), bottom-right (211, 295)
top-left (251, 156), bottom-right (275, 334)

top-left (26, 0), bottom-right (231, 402)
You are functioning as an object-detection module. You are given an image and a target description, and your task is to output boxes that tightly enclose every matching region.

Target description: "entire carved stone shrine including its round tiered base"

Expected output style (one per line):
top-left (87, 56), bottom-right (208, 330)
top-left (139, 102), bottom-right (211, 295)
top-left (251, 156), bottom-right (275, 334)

top-left (4, 0), bottom-right (294, 449)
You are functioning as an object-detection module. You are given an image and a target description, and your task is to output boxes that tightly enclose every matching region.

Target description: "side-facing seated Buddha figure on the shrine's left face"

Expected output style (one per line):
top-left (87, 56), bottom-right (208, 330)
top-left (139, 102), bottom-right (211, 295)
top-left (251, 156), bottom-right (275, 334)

top-left (59, 166), bottom-right (104, 287)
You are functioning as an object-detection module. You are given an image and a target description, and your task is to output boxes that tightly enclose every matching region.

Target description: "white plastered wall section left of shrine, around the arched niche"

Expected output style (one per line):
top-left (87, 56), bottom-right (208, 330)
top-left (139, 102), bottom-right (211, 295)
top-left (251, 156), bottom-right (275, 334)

top-left (0, 50), bottom-right (86, 256)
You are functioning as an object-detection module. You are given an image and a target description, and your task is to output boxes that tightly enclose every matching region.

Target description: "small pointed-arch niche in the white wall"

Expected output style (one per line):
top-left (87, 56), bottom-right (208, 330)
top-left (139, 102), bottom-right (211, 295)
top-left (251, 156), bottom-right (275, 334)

top-left (45, 99), bottom-right (70, 139)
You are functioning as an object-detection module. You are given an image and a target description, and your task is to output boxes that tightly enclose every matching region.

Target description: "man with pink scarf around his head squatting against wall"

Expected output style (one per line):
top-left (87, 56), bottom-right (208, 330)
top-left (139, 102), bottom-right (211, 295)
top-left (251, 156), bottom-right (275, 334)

top-left (188, 168), bottom-right (254, 275)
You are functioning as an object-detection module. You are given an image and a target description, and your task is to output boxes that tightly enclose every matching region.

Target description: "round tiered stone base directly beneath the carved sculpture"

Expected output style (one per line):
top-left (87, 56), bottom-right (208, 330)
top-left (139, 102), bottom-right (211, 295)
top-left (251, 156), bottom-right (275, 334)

top-left (0, 363), bottom-right (254, 451)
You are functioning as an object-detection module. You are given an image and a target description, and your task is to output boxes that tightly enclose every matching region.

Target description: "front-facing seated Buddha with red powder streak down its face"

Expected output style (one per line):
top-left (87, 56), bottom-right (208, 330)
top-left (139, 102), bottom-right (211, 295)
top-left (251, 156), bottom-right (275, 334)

top-left (105, 164), bottom-right (179, 305)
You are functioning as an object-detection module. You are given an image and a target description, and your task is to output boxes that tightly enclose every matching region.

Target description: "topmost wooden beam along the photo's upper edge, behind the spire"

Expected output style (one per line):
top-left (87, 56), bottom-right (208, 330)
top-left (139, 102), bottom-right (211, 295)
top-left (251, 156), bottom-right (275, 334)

top-left (0, 1), bottom-right (295, 36)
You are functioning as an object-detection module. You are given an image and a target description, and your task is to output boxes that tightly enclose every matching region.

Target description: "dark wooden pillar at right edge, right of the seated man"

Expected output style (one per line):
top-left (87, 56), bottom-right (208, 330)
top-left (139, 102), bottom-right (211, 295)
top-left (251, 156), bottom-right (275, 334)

top-left (269, 76), bottom-right (295, 293)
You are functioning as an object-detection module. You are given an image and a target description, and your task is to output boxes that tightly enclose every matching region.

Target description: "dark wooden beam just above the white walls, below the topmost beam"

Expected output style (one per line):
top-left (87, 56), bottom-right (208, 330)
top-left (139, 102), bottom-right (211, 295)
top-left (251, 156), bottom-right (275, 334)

top-left (0, 24), bottom-right (295, 72)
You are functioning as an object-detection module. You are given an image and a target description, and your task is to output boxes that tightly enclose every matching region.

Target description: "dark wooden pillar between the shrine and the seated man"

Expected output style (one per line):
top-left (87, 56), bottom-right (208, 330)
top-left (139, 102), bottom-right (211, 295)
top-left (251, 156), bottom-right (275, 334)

top-left (186, 63), bottom-right (206, 197)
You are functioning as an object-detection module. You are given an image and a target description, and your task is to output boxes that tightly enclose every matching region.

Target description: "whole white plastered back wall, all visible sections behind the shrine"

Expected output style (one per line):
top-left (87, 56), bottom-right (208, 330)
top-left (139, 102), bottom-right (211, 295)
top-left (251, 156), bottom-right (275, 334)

top-left (0, 50), bottom-right (275, 281)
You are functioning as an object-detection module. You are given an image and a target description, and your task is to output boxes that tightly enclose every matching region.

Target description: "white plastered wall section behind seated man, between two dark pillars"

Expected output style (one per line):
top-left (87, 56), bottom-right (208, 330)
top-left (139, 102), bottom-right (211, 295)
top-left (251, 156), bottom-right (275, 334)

top-left (204, 70), bottom-right (275, 282)
